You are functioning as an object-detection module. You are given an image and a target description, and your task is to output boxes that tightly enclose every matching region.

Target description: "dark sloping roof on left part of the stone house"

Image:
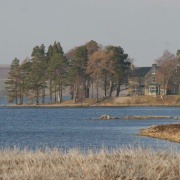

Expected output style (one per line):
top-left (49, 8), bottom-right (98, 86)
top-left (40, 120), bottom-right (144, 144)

top-left (129, 67), bottom-right (152, 77)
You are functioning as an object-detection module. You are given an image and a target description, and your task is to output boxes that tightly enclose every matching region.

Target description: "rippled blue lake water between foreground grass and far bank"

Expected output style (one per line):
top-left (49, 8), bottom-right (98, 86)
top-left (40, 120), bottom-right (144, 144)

top-left (0, 97), bottom-right (180, 149)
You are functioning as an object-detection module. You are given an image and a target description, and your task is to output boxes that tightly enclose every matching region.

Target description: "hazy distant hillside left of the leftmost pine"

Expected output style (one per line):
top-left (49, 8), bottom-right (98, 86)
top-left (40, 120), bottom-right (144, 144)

top-left (0, 64), bottom-right (10, 97)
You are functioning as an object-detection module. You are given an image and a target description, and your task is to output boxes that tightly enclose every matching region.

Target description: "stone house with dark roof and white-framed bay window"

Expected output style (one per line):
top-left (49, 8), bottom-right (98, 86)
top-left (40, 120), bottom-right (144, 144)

top-left (128, 64), bottom-right (180, 96)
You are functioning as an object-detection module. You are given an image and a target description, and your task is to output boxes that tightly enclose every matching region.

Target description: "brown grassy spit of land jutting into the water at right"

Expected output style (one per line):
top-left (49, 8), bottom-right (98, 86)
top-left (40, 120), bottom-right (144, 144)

top-left (137, 124), bottom-right (180, 142)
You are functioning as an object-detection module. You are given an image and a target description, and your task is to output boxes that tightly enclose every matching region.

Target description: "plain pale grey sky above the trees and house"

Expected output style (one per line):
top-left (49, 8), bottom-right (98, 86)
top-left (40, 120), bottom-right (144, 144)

top-left (0, 0), bottom-right (180, 67)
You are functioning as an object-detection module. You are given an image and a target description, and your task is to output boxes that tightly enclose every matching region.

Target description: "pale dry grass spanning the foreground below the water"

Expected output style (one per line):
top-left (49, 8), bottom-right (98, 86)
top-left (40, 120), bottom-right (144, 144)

top-left (0, 148), bottom-right (180, 180)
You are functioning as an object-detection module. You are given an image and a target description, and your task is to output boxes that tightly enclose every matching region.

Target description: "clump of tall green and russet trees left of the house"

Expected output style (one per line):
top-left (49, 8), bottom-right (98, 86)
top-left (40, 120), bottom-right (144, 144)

top-left (5, 40), bottom-right (131, 104)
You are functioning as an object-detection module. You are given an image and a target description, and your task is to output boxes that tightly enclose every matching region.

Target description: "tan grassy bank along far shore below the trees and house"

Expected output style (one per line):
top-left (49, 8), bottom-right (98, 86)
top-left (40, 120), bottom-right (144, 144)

top-left (8, 95), bottom-right (180, 107)
